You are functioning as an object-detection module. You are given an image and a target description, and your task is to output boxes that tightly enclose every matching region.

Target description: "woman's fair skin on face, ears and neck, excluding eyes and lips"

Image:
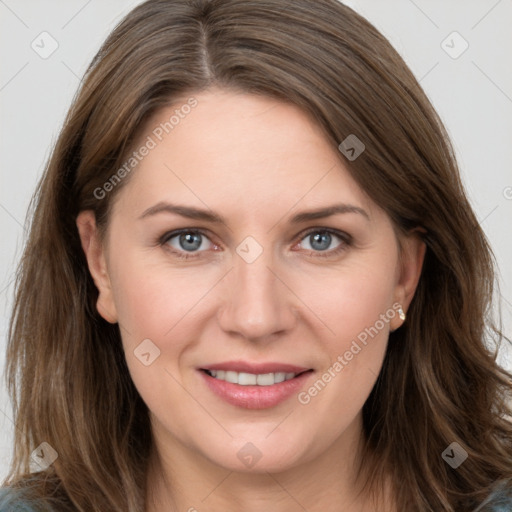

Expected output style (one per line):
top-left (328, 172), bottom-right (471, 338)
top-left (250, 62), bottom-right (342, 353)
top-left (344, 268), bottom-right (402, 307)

top-left (77, 89), bottom-right (425, 512)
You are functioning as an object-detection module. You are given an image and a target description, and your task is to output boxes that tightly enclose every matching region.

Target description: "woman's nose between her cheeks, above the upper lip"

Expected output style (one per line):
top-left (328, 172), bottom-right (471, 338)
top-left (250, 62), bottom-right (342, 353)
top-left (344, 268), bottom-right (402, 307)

top-left (218, 245), bottom-right (297, 342)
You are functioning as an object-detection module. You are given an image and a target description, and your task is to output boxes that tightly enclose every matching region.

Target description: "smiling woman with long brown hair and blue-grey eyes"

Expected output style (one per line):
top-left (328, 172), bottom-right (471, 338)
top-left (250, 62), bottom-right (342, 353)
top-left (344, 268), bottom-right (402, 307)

top-left (3, 0), bottom-right (512, 512)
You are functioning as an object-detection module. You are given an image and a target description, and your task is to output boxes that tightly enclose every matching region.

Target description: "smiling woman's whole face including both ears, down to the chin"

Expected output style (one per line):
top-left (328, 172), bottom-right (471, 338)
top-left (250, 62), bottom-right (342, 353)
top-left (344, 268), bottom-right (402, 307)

top-left (78, 90), bottom-right (424, 471)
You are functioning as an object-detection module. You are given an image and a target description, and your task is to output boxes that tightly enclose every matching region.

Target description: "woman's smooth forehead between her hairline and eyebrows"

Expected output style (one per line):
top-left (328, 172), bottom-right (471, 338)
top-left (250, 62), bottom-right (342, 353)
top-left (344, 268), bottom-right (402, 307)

top-left (112, 89), bottom-right (375, 220)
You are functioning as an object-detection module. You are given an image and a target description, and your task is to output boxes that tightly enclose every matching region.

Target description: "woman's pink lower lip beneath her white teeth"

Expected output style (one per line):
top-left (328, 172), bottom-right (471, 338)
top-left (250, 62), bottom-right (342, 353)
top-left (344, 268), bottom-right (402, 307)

top-left (199, 370), bottom-right (313, 409)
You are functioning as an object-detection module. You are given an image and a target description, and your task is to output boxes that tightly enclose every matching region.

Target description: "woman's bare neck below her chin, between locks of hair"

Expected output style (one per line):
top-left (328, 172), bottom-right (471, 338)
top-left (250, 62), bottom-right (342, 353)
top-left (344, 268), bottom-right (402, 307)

top-left (146, 417), bottom-right (392, 512)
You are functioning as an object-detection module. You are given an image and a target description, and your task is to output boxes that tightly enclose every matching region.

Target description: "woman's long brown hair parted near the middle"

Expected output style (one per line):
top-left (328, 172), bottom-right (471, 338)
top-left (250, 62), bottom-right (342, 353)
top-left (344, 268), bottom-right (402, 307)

top-left (4, 0), bottom-right (512, 512)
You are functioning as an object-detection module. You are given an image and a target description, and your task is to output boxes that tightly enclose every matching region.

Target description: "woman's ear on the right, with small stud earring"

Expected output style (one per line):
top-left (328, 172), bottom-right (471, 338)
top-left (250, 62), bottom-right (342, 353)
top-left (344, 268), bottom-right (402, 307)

top-left (390, 228), bottom-right (427, 331)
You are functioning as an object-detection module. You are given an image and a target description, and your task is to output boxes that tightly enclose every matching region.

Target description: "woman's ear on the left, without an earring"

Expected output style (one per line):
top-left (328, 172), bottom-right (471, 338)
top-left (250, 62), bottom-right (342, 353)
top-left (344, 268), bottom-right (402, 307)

top-left (76, 210), bottom-right (117, 324)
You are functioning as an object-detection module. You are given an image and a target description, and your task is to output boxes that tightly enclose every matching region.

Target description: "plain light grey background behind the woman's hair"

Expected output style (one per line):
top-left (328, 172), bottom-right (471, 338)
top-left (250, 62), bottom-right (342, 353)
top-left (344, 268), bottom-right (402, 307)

top-left (0, 0), bottom-right (512, 478)
